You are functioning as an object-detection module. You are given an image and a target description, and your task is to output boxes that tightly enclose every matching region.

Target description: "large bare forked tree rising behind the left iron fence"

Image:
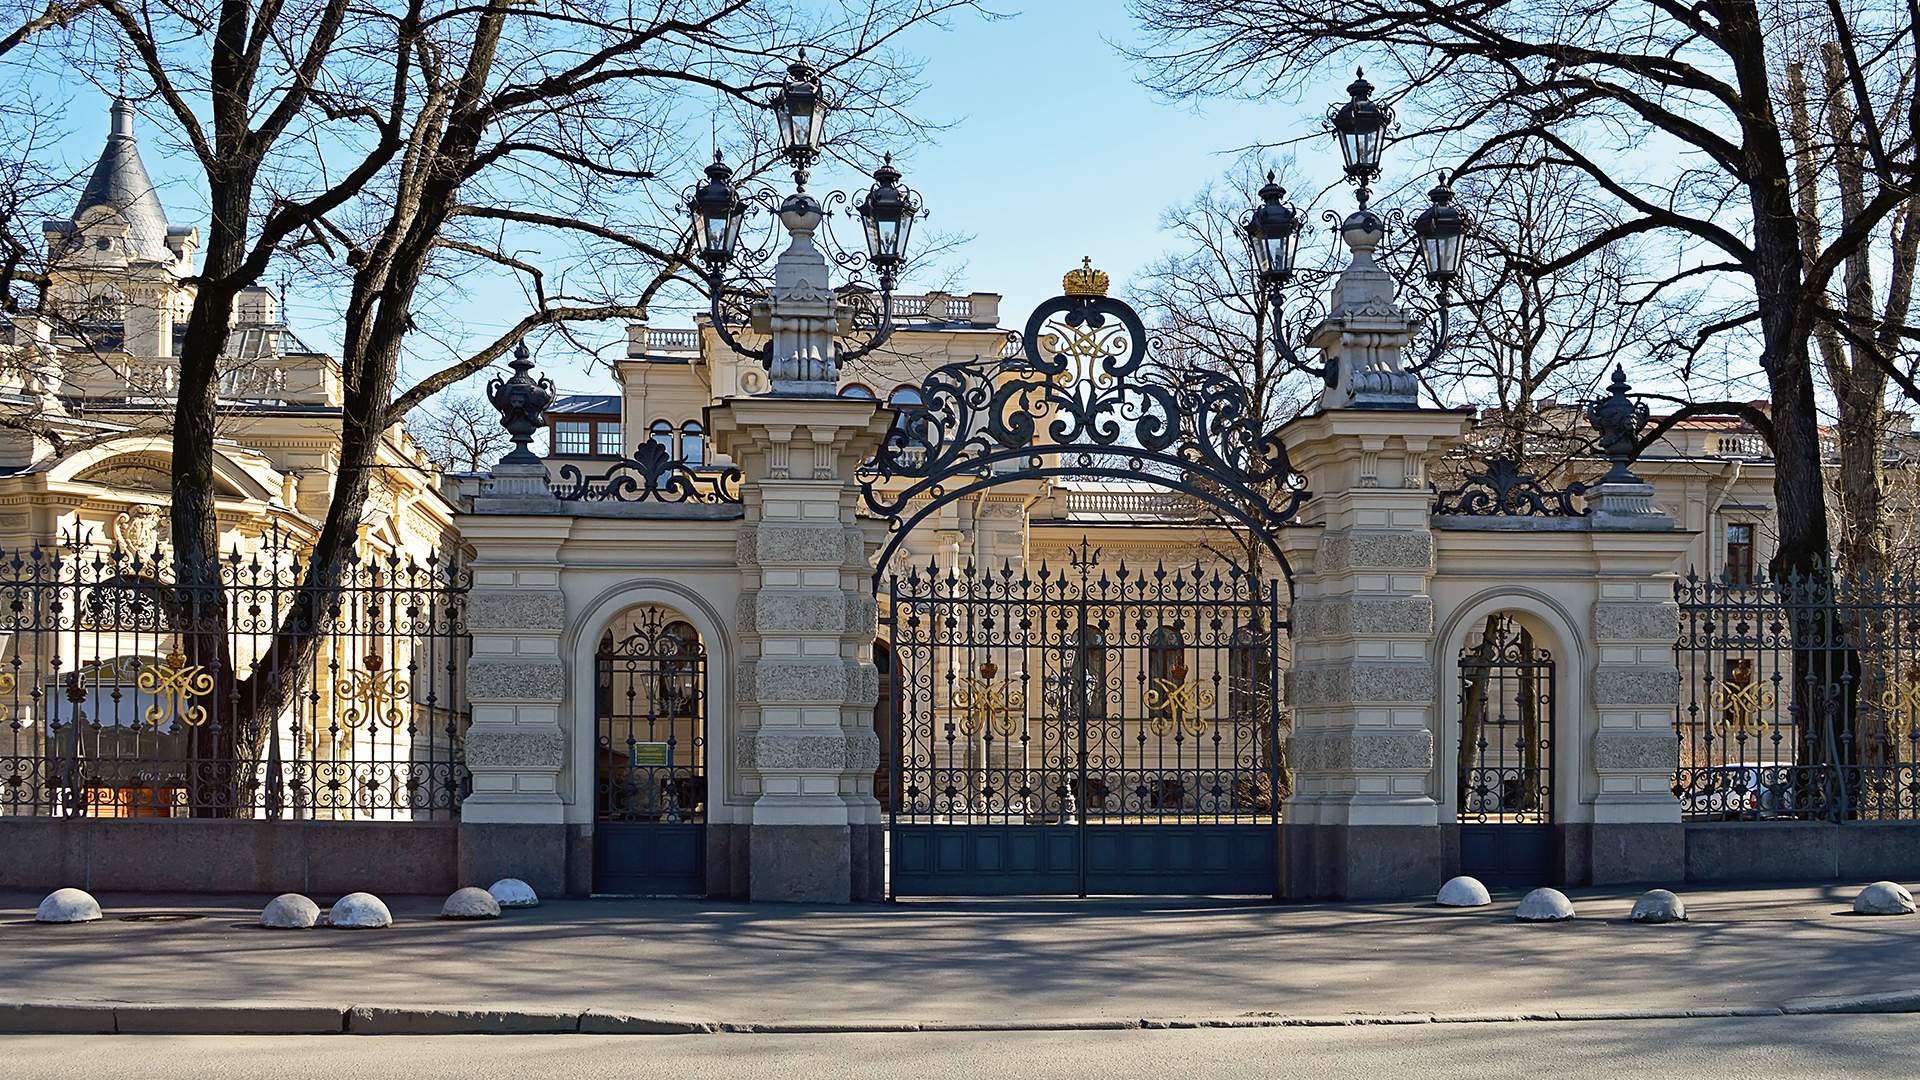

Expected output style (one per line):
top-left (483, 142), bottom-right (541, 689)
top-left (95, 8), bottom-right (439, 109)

top-left (18, 0), bottom-right (973, 799)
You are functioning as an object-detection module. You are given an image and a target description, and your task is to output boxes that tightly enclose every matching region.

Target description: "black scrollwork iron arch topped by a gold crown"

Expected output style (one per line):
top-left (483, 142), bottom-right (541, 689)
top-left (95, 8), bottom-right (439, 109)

top-left (860, 284), bottom-right (1309, 580)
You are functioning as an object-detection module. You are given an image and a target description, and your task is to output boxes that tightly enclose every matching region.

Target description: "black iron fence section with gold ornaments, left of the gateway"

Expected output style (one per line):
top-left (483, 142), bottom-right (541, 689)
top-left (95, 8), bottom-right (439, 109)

top-left (0, 534), bottom-right (468, 821)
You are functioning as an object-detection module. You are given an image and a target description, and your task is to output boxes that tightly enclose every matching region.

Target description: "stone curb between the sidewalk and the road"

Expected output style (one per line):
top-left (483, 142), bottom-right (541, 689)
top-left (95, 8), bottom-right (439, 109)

top-left (0, 990), bottom-right (1920, 1036)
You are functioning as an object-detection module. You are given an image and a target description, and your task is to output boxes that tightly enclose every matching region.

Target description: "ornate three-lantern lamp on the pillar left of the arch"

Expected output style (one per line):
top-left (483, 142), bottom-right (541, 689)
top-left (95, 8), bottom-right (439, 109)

top-left (687, 52), bottom-right (922, 396)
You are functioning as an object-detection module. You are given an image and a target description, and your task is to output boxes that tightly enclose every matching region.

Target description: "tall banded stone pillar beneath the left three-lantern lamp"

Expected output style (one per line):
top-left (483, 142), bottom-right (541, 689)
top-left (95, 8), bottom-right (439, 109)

top-left (708, 382), bottom-right (891, 903)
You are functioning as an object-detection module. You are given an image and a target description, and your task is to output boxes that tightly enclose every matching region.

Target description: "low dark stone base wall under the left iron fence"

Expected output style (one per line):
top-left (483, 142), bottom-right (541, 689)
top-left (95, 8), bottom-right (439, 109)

top-left (0, 817), bottom-right (456, 897)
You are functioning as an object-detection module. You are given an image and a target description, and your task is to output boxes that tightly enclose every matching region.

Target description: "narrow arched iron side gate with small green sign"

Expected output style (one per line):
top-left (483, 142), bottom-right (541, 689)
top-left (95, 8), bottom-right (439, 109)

top-left (593, 607), bottom-right (707, 896)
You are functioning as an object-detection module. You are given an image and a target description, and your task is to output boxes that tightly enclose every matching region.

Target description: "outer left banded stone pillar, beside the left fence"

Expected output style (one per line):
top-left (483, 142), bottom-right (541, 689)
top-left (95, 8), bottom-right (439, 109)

top-left (461, 511), bottom-right (572, 896)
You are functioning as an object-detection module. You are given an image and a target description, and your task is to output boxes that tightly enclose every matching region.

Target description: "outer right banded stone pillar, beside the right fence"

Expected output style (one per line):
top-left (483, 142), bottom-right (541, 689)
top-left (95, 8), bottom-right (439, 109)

top-left (1588, 507), bottom-right (1693, 884)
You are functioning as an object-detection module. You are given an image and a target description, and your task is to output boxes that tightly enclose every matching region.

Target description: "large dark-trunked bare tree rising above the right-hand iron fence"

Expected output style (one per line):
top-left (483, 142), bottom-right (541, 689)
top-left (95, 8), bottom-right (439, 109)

top-left (1133, 0), bottom-right (1920, 588)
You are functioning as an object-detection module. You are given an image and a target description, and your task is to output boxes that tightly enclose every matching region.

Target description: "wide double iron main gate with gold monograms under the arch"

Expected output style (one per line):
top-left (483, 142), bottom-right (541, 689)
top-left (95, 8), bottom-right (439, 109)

top-left (885, 548), bottom-right (1286, 896)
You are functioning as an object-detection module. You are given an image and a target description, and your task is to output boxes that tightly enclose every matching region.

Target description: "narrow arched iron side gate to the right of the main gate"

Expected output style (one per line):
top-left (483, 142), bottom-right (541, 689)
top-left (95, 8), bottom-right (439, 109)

top-left (1457, 615), bottom-right (1555, 886)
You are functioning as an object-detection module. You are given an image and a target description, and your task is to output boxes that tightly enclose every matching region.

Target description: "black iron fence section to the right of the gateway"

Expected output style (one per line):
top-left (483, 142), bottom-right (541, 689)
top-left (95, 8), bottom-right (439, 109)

top-left (1674, 575), bottom-right (1920, 821)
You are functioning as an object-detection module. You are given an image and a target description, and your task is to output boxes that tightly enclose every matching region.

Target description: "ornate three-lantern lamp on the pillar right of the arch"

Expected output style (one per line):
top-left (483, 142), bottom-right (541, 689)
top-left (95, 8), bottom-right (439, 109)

top-left (1240, 71), bottom-right (1471, 405)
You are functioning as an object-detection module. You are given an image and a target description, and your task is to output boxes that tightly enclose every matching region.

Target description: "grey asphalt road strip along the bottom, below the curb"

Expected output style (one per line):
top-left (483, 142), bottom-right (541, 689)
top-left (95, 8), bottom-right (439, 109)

top-left (0, 1015), bottom-right (1920, 1080)
